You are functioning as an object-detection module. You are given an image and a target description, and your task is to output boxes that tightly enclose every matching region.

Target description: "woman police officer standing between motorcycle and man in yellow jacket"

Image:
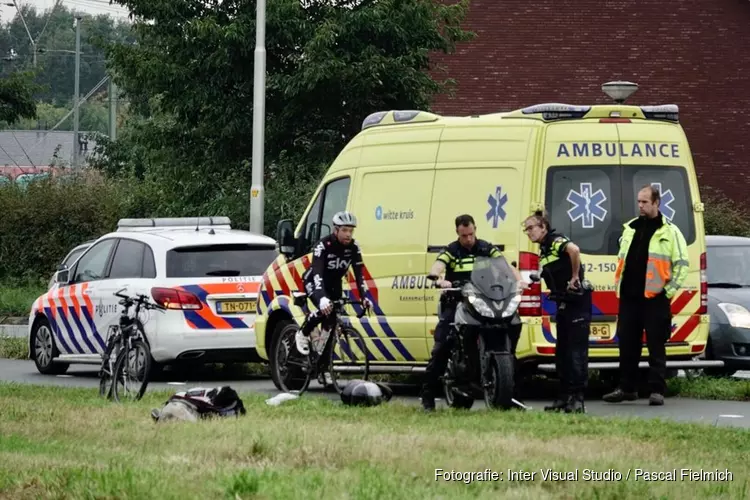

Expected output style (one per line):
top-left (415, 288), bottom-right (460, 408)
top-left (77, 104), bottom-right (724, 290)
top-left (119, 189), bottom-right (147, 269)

top-left (524, 211), bottom-right (591, 413)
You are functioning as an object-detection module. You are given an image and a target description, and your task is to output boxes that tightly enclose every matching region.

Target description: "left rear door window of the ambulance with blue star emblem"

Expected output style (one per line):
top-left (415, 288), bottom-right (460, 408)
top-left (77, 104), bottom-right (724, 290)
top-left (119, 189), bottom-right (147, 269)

top-left (544, 165), bottom-right (623, 255)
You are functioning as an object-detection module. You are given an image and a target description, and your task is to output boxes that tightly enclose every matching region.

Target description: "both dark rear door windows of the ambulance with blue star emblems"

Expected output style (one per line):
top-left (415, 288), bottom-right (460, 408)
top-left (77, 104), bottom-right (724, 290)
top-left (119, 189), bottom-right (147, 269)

top-left (545, 165), bottom-right (695, 255)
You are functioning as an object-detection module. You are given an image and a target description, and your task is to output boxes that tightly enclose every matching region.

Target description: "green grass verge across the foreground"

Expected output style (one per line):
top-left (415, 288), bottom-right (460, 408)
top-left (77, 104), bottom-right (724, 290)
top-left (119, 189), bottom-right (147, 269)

top-left (0, 384), bottom-right (750, 500)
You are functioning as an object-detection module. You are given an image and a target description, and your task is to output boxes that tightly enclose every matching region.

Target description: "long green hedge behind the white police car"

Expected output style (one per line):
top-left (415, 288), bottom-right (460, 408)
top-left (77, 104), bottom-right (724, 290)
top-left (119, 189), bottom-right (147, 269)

top-left (0, 154), bottom-right (325, 284)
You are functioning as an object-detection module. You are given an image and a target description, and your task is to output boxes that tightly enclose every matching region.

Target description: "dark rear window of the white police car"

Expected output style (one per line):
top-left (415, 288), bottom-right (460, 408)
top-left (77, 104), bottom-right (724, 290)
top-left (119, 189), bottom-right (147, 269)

top-left (167, 244), bottom-right (278, 278)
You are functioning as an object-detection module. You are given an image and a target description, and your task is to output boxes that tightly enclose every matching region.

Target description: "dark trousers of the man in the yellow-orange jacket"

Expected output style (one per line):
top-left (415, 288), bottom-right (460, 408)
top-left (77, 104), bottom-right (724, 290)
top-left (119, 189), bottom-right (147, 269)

top-left (617, 293), bottom-right (672, 395)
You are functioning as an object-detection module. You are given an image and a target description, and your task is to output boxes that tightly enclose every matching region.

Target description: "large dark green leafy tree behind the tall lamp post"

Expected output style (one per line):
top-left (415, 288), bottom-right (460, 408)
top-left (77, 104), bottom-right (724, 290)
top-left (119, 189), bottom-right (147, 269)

top-left (100, 0), bottom-right (472, 233)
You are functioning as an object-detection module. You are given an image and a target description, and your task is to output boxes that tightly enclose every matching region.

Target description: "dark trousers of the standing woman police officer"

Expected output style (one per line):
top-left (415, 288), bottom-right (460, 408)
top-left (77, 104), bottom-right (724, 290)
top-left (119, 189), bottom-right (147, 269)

top-left (555, 304), bottom-right (591, 400)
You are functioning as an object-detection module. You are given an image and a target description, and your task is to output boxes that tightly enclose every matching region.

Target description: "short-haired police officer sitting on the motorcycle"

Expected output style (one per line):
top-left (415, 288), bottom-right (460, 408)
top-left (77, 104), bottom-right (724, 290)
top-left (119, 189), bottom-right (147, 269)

top-left (422, 214), bottom-right (525, 411)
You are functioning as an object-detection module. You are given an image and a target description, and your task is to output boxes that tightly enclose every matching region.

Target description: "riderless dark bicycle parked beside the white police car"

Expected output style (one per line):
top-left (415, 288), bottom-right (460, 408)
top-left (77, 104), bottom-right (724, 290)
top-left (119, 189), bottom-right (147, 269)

top-left (99, 288), bottom-right (166, 402)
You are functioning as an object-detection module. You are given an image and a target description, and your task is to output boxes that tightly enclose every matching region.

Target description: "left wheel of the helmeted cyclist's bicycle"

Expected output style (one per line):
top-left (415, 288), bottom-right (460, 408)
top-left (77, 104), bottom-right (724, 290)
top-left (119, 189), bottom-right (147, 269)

top-left (273, 321), bottom-right (312, 396)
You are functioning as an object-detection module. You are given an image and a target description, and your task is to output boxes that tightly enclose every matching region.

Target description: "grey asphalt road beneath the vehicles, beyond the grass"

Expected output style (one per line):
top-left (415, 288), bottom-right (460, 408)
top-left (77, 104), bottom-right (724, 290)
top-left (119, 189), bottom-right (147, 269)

top-left (0, 359), bottom-right (750, 429)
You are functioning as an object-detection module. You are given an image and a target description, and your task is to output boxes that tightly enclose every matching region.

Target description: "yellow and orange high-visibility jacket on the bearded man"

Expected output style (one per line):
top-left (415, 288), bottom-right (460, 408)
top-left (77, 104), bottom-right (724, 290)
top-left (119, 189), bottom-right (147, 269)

top-left (615, 215), bottom-right (690, 299)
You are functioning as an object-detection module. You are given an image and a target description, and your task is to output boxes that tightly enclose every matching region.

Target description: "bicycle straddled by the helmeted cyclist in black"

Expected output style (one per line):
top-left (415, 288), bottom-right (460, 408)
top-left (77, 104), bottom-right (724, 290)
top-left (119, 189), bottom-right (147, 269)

top-left (273, 294), bottom-right (371, 396)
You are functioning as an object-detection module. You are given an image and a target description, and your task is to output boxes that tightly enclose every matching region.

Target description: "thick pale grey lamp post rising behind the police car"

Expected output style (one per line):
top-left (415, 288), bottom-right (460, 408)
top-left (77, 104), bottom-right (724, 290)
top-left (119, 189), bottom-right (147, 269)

top-left (250, 0), bottom-right (266, 234)
